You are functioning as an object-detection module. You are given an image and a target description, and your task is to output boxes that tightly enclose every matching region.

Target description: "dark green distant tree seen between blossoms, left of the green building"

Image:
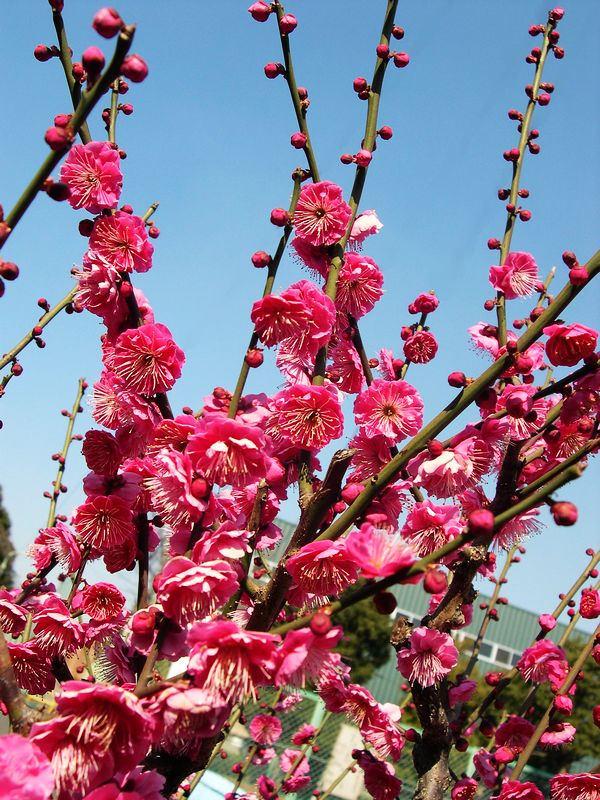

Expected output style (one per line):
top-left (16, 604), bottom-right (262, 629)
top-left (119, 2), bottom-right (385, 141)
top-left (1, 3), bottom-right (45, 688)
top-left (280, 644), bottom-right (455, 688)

top-left (335, 600), bottom-right (393, 683)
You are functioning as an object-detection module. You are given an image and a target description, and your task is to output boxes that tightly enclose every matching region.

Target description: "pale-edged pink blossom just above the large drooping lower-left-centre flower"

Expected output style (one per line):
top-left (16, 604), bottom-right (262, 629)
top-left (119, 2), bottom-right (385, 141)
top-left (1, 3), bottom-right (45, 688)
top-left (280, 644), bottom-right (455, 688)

top-left (154, 556), bottom-right (238, 627)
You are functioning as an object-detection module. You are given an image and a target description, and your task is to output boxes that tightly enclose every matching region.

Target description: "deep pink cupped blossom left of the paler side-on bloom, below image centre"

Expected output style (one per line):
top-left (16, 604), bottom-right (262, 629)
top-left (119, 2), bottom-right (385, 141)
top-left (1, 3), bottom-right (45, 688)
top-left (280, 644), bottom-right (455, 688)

top-left (286, 539), bottom-right (358, 595)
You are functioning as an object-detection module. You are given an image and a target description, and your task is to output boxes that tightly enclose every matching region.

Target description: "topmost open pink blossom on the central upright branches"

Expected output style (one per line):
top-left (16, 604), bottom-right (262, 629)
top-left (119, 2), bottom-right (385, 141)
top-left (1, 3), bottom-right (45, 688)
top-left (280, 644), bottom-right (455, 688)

top-left (294, 181), bottom-right (352, 246)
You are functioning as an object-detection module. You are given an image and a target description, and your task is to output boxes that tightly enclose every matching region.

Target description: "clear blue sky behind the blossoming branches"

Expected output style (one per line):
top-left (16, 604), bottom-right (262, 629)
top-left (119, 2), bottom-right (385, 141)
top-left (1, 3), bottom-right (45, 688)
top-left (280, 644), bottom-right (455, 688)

top-left (0, 0), bottom-right (600, 624)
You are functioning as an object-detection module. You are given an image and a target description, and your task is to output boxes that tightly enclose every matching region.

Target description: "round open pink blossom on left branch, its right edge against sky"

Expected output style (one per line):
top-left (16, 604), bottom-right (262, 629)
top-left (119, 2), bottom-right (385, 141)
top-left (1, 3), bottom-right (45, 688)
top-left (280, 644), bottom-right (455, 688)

top-left (111, 323), bottom-right (185, 395)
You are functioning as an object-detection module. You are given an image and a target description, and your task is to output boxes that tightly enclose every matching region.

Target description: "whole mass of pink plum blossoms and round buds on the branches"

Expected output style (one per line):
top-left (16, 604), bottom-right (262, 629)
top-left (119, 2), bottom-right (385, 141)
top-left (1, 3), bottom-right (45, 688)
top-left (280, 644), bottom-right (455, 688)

top-left (0, 2), bottom-right (600, 800)
